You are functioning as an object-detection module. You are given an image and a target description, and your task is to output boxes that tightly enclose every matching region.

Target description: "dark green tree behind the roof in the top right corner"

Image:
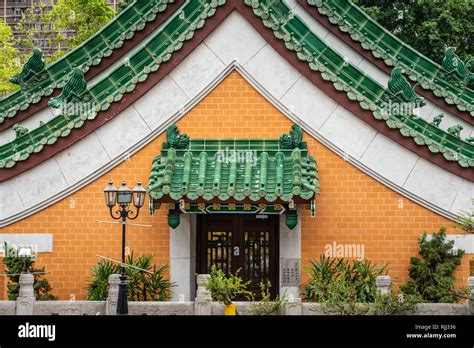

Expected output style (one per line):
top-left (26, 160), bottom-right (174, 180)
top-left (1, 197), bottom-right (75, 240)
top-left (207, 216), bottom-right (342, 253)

top-left (354, 0), bottom-right (474, 64)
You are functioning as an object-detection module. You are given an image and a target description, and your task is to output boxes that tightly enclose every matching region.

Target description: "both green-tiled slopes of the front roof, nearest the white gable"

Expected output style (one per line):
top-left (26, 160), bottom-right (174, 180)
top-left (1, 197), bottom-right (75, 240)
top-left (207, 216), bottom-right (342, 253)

top-left (0, 0), bottom-right (474, 169)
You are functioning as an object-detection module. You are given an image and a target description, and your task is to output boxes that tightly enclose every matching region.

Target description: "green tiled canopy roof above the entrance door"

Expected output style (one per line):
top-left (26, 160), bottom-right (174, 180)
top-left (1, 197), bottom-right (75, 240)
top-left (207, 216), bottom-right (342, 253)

top-left (148, 125), bottom-right (319, 203)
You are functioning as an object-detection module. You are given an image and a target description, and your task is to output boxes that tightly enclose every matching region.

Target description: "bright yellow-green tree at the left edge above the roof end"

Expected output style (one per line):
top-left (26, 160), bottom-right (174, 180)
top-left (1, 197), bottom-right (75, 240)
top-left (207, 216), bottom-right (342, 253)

top-left (0, 19), bottom-right (21, 98)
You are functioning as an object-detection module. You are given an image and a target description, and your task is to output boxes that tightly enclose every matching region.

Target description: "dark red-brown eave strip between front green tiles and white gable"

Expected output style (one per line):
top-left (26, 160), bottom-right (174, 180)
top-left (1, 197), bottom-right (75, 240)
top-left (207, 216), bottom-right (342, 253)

top-left (0, 1), bottom-right (474, 181)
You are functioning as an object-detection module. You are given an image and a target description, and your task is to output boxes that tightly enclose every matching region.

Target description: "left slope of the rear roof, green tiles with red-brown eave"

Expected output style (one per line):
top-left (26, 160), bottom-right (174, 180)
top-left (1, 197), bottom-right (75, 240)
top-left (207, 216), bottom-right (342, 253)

top-left (0, 0), bottom-right (185, 131)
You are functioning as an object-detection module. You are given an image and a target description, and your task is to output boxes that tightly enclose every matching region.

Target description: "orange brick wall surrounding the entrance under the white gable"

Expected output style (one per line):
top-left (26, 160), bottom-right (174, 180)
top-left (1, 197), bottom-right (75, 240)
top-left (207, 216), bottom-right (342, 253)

top-left (1, 72), bottom-right (474, 299)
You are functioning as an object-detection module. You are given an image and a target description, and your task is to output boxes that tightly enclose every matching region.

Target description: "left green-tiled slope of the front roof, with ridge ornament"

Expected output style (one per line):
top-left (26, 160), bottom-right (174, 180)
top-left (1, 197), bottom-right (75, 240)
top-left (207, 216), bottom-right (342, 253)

top-left (0, 0), bottom-right (225, 168)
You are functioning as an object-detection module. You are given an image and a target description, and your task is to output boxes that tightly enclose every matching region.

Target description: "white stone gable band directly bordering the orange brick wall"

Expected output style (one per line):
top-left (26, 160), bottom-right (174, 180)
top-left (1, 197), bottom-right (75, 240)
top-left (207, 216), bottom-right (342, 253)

top-left (0, 12), bottom-right (474, 227)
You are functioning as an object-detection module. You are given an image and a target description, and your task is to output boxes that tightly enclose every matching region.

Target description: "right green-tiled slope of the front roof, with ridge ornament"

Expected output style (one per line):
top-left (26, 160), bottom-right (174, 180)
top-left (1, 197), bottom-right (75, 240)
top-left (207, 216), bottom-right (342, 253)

top-left (245, 0), bottom-right (474, 167)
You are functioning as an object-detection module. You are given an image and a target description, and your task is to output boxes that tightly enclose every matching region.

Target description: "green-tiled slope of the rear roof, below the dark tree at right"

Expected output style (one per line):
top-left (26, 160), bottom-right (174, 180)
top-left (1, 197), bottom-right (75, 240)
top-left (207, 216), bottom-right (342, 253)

top-left (307, 0), bottom-right (474, 117)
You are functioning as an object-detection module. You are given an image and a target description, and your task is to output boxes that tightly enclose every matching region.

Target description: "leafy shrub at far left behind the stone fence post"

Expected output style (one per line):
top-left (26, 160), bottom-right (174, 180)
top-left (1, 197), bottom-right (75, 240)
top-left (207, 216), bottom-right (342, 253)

top-left (3, 243), bottom-right (57, 301)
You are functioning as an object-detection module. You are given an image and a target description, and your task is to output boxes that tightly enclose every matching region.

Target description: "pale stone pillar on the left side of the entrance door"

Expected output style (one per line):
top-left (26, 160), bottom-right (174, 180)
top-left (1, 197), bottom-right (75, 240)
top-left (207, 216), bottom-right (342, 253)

top-left (170, 214), bottom-right (196, 301)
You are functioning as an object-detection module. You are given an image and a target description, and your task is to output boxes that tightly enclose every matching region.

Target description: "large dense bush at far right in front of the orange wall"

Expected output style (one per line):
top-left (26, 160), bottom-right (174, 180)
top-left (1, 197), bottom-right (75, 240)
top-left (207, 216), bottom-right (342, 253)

top-left (400, 227), bottom-right (469, 303)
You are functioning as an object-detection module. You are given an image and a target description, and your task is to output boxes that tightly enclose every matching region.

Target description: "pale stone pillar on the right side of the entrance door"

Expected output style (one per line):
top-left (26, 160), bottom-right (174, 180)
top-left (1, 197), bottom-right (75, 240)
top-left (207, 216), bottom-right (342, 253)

top-left (280, 210), bottom-right (301, 303)
